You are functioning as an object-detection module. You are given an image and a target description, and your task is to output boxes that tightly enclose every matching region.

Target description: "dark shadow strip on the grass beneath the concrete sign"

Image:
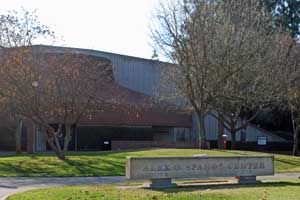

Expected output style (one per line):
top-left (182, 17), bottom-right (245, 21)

top-left (147, 181), bottom-right (300, 193)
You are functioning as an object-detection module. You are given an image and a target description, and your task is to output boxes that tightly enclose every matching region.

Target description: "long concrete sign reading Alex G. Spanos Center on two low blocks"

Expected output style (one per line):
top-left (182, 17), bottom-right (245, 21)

top-left (126, 156), bottom-right (274, 187)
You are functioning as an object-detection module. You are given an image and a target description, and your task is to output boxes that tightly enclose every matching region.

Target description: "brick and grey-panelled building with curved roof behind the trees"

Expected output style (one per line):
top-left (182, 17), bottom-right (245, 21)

top-left (0, 45), bottom-right (289, 152)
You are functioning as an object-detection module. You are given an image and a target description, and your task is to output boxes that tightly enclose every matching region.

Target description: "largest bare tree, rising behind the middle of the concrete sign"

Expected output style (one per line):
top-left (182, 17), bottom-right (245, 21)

top-left (152, 0), bottom-right (290, 147)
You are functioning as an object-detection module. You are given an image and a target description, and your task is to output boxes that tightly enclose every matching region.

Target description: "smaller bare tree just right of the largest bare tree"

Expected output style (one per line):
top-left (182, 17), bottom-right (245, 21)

top-left (214, 34), bottom-right (290, 149)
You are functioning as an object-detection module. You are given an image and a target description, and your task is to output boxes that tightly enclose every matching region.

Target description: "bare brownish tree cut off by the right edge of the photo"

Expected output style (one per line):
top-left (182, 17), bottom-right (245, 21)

top-left (265, 38), bottom-right (300, 156)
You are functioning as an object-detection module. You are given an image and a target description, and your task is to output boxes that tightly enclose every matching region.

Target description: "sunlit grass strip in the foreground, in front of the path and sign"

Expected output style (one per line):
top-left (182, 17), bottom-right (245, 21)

top-left (8, 180), bottom-right (300, 200)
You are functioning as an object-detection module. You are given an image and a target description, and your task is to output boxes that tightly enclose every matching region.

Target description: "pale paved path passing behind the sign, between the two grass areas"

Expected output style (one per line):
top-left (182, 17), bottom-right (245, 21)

top-left (0, 173), bottom-right (300, 200)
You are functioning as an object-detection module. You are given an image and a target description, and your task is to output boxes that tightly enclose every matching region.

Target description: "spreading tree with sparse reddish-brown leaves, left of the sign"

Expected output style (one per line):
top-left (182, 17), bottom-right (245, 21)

top-left (0, 47), bottom-right (113, 159)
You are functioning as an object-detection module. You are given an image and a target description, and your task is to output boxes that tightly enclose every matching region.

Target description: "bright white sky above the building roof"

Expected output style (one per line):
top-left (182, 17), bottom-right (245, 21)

top-left (0, 0), bottom-right (157, 58)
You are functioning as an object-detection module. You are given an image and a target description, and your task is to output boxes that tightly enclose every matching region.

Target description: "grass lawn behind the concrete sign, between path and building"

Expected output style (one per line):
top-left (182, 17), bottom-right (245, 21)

top-left (0, 149), bottom-right (300, 177)
